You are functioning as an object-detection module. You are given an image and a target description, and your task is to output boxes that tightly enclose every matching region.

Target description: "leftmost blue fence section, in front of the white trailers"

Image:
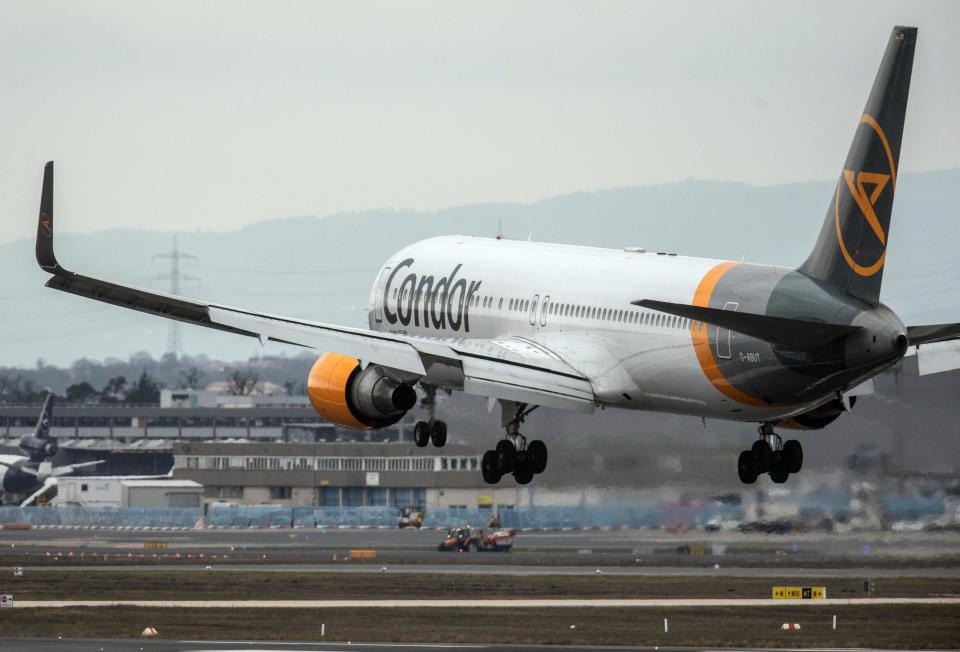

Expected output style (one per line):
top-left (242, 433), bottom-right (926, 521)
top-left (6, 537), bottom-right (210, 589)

top-left (0, 506), bottom-right (203, 529)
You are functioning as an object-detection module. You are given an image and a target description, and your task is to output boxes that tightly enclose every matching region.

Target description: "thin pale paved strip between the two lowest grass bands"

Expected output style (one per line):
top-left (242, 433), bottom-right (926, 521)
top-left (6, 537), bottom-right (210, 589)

top-left (14, 598), bottom-right (960, 609)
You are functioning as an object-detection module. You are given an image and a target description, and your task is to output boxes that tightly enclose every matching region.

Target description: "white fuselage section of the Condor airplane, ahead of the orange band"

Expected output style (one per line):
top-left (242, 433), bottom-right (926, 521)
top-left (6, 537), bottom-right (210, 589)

top-left (369, 236), bottom-right (817, 421)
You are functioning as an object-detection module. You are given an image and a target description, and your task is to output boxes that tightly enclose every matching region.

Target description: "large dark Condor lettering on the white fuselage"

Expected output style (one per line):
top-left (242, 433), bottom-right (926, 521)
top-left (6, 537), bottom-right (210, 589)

top-left (383, 258), bottom-right (482, 333)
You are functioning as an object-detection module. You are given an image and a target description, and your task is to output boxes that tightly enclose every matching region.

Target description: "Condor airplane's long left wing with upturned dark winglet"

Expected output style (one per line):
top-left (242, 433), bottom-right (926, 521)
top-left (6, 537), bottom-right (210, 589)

top-left (36, 161), bottom-right (594, 412)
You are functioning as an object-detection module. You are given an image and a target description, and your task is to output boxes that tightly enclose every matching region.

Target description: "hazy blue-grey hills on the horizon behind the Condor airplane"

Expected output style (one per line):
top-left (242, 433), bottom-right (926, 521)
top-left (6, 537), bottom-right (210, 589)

top-left (0, 169), bottom-right (960, 366)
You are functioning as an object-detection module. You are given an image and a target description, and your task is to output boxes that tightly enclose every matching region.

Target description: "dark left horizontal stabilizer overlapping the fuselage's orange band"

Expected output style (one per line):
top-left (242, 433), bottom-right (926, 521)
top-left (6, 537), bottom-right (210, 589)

top-left (633, 299), bottom-right (860, 351)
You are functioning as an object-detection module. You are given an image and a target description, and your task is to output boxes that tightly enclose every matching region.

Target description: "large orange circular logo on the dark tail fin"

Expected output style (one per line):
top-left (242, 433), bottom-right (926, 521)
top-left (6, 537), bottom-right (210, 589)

top-left (834, 114), bottom-right (897, 276)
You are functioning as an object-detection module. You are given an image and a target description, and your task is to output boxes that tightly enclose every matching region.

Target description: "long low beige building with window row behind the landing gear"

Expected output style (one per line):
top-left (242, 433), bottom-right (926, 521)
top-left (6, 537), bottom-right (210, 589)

top-left (173, 441), bottom-right (526, 508)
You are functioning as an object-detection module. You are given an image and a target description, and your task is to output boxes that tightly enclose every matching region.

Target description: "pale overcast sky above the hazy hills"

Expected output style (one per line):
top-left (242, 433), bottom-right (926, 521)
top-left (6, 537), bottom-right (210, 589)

top-left (0, 0), bottom-right (960, 241)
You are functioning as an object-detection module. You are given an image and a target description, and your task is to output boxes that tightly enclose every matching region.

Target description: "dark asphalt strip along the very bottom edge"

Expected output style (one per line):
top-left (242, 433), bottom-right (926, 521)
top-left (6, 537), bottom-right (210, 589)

top-left (0, 638), bottom-right (944, 652)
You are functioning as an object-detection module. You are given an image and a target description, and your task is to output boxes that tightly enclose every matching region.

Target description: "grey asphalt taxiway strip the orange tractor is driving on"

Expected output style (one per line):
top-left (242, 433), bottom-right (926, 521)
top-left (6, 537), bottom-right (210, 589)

top-left (0, 528), bottom-right (960, 565)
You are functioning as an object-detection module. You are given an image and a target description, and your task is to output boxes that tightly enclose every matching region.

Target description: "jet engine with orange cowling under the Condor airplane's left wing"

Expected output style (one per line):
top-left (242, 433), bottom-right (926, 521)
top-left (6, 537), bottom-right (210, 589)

top-left (307, 353), bottom-right (417, 430)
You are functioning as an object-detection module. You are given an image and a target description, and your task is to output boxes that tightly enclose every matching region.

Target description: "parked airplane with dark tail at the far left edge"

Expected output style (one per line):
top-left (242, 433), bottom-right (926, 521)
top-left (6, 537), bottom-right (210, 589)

top-left (0, 393), bottom-right (103, 502)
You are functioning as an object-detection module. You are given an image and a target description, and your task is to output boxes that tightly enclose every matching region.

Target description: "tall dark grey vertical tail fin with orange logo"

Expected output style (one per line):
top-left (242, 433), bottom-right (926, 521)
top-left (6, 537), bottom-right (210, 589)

top-left (799, 27), bottom-right (917, 305)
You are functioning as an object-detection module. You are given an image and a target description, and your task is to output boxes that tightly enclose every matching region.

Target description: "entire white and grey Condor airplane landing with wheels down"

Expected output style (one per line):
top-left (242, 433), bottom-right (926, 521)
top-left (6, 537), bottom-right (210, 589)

top-left (30, 27), bottom-right (960, 484)
